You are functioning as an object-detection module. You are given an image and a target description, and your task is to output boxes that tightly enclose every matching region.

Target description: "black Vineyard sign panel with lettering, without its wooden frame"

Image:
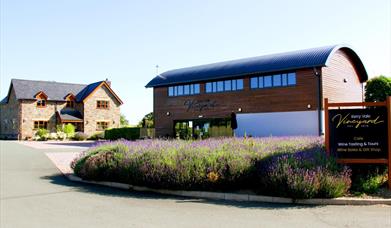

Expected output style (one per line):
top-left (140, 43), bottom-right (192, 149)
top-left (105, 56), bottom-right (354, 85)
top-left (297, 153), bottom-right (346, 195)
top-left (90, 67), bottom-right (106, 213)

top-left (328, 107), bottom-right (388, 159)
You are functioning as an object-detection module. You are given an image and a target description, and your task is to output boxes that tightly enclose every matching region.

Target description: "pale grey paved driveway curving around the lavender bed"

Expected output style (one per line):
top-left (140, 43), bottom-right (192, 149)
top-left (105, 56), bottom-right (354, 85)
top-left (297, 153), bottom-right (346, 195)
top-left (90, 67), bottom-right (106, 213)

top-left (0, 141), bottom-right (391, 228)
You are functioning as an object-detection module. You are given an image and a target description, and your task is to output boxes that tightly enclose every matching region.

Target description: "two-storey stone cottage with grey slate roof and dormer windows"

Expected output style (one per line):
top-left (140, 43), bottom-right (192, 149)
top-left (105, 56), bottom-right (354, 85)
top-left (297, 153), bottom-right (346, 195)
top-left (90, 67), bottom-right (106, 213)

top-left (0, 79), bottom-right (123, 139)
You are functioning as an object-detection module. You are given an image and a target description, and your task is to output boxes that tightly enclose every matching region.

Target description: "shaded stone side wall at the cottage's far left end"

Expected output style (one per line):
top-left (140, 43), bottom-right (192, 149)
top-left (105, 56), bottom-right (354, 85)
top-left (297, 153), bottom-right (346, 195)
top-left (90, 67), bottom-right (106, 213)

top-left (0, 88), bottom-right (20, 138)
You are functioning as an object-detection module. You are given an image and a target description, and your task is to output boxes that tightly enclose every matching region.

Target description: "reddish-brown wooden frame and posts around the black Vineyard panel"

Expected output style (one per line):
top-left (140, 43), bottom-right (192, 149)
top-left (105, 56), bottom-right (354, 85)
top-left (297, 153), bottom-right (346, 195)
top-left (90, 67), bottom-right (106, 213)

top-left (324, 97), bottom-right (391, 190)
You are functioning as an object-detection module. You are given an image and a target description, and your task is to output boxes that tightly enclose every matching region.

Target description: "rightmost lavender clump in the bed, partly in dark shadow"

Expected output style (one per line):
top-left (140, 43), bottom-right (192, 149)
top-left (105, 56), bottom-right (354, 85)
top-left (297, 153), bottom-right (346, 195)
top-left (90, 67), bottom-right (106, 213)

top-left (257, 147), bottom-right (351, 198)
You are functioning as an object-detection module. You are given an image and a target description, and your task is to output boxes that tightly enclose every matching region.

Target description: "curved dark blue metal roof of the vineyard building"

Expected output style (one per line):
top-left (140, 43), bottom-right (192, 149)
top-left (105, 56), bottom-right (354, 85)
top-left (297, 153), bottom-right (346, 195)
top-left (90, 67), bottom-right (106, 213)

top-left (146, 45), bottom-right (368, 88)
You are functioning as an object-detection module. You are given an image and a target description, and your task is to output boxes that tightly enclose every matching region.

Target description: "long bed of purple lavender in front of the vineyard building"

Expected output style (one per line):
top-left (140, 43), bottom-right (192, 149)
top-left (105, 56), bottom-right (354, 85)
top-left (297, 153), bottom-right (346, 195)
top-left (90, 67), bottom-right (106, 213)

top-left (72, 137), bottom-right (351, 198)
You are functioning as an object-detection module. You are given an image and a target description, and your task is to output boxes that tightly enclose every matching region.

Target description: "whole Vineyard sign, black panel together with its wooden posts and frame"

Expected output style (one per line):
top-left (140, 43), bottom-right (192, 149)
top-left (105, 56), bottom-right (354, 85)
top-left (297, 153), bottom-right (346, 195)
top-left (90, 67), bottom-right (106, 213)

top-left (324, 96), bottom-right (391, 190)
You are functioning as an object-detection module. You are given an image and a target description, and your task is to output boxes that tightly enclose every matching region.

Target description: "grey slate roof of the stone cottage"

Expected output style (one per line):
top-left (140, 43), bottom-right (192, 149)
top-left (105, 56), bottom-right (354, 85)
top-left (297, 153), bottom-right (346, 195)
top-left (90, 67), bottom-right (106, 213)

top-left (1, 79), bottom-right (112, 103)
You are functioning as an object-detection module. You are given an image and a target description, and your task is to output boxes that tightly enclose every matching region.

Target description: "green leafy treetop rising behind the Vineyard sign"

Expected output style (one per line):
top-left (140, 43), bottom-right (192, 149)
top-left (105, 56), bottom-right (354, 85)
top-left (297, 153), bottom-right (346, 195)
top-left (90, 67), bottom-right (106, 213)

top-left (365, 75), bottom-right (391, 102)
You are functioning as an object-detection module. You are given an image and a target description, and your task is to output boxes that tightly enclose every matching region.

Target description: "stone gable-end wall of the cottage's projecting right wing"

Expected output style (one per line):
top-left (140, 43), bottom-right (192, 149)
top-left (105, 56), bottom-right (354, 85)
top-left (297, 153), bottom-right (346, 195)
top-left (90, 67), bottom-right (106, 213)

top-left (84, 86), bottom-right (121, 136)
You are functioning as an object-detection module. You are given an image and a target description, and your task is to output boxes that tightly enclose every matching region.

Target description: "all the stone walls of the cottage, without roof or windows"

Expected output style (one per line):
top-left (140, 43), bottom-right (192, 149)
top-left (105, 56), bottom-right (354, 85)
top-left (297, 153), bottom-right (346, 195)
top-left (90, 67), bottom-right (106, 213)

top-left (0, 82), bottom-right (120, 139)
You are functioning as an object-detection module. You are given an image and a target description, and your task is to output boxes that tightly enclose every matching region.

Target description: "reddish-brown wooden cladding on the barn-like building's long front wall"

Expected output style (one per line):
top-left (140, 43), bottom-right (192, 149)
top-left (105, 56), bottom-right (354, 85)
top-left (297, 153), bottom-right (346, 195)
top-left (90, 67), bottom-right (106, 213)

top-left (154, 69), bottom-right (319, 136)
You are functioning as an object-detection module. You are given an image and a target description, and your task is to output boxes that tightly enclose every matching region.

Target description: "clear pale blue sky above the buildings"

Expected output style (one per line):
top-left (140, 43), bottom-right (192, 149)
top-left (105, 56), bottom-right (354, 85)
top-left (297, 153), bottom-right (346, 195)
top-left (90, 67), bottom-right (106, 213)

top-left (0, 0), bottom-right (391, 124)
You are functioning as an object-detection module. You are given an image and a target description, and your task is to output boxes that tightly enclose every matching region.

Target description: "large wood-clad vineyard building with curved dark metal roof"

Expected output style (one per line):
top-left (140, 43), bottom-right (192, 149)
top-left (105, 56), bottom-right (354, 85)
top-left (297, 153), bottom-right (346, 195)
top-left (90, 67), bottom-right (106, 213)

top-left (146, 45), bottom-right (368, 138)
